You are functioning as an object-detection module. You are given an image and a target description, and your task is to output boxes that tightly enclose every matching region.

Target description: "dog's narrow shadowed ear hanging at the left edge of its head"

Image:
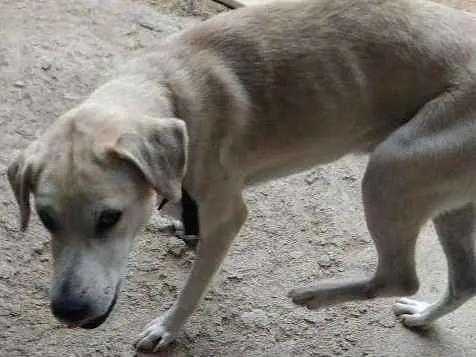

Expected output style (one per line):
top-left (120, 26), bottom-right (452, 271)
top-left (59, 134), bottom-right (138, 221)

top-left (7, 149), bottom-right (41, 231)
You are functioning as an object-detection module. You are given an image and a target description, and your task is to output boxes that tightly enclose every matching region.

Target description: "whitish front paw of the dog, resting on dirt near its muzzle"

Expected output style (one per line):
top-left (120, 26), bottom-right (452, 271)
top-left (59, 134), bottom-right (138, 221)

top-left (134, 308), bottom-right (181, 353)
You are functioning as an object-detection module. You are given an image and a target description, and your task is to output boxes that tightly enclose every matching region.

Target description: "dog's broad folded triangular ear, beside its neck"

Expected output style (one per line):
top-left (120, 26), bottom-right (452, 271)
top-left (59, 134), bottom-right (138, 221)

top-left (112, 117), bottom-right (188, 202)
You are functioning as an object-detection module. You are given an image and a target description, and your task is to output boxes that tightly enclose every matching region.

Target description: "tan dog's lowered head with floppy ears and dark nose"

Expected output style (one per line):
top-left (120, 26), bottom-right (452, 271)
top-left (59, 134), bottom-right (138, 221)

top-left (8, 108), bottom-right (187, 328)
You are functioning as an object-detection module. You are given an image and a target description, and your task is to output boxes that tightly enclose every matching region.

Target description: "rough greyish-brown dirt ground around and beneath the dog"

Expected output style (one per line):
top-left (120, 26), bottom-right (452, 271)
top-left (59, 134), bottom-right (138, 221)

top-left (0, 0), bottom-right (476, 357)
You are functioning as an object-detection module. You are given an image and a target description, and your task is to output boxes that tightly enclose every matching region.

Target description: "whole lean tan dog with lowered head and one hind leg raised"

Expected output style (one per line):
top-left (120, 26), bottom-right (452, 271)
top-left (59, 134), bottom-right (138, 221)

top-left (8, 0), bottom-right (476, 350)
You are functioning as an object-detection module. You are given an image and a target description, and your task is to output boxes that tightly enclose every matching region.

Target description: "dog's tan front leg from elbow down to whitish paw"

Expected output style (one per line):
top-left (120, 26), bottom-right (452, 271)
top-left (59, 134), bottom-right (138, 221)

top-left (135, 190), bottom-right (247, 352)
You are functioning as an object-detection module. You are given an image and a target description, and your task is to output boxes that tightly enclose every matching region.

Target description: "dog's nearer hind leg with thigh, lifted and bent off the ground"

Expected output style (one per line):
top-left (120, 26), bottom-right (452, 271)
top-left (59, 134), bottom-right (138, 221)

top-left (290, 85), bottom-right (476, 309)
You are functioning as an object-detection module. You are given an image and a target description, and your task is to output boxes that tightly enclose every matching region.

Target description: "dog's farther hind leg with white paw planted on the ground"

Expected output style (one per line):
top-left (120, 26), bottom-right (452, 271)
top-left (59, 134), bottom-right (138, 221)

top-left (394, 203), bottom-right (476, 327)
